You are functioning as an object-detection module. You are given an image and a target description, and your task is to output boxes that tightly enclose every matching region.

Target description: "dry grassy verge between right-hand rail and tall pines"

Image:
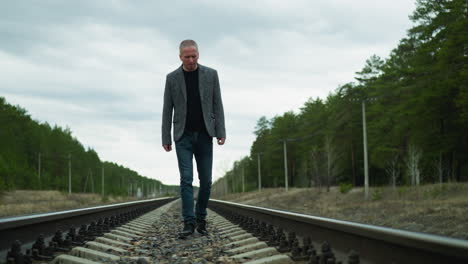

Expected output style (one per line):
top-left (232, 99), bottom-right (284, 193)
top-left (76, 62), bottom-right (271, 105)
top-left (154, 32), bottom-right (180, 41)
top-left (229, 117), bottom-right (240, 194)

top-left (220, 183), bottom-right (468, 239)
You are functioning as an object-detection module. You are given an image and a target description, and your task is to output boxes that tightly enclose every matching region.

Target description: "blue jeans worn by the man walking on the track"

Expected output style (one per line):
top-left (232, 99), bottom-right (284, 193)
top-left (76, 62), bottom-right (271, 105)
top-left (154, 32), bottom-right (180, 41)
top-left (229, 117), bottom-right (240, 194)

top-left (175, 131), bottom-right (213, 223)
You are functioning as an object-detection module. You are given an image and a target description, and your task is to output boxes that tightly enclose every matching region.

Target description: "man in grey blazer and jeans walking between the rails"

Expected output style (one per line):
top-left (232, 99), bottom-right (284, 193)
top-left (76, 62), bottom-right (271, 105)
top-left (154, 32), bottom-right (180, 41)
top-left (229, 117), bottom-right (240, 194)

top-left (162, 40), bottom-right (226, 238)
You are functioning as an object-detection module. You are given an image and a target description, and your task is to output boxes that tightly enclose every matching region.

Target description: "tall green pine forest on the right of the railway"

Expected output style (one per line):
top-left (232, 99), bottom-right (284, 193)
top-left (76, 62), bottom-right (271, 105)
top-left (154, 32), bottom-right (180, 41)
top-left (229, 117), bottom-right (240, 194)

top-left (213, 0), bottom-right (468, 193)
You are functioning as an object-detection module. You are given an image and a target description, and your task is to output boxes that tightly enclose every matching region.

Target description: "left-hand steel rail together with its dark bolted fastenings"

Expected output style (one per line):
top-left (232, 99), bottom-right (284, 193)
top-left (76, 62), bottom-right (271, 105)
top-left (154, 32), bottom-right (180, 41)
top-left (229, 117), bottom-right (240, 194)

top-left (0, 198), bottom-right (174, 263)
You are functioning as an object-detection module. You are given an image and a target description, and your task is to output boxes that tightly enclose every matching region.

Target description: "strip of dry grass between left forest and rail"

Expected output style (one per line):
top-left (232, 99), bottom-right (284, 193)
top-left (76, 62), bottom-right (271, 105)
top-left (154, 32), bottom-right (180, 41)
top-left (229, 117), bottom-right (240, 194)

top-left (0, 190), bottom-right (136, 217)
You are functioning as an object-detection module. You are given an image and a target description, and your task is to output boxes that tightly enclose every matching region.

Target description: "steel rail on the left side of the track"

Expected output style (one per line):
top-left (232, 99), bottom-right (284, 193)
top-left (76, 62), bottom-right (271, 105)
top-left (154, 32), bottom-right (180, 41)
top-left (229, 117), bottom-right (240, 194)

top-left (0, 197), bottom-right (175, 255)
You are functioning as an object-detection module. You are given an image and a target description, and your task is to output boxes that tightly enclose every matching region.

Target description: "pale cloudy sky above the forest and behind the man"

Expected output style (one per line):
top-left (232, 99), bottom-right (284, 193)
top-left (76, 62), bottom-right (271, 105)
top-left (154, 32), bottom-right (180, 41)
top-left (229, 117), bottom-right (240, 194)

top-left (0, 0), bottom-right (415, 184)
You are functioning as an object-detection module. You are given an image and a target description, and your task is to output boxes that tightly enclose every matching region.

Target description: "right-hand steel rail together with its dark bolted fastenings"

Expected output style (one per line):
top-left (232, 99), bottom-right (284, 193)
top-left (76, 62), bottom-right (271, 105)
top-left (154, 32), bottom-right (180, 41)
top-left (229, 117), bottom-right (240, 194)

top-left (210, 200), bottom-right (468, 264)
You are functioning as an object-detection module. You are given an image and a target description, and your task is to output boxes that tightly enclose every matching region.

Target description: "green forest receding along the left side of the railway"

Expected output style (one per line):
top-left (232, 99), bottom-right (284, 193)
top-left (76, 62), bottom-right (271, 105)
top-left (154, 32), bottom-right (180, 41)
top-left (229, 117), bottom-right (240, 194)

top-left (0, 97), bottom-right (172, 197)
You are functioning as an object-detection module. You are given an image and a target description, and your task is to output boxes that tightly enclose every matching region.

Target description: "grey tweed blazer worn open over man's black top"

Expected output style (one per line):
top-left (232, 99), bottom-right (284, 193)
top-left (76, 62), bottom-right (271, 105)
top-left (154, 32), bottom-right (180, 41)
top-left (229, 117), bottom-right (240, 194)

top-left (162, 64), bottom-right (226, 145)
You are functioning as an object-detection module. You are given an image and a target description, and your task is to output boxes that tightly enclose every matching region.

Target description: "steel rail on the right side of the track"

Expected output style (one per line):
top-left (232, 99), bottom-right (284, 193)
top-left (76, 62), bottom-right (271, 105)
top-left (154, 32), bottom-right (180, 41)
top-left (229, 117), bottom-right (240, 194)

top-left (209, 199), bottom-right (468, 264)
